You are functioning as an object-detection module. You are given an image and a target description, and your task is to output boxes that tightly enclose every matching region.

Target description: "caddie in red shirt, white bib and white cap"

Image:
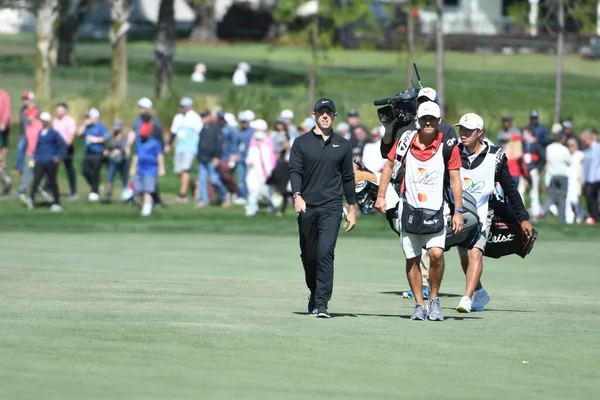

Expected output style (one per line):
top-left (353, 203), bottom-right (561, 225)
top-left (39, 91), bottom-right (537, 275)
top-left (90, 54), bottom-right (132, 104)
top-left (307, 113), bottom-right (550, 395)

top-left (375, 101), bottom-right (463, 321)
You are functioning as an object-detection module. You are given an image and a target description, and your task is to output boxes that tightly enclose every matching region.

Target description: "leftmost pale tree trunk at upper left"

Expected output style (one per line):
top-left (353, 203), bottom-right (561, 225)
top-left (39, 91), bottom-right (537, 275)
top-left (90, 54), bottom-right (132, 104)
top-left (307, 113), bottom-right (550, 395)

top-left (34, 0), bottom-right (58, 105)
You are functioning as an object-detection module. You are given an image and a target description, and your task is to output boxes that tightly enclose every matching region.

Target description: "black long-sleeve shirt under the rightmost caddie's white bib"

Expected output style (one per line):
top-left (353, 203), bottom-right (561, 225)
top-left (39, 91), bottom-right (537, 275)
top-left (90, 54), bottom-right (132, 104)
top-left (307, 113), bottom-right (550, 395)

top-left (458, 144), bottom-right (529, 222)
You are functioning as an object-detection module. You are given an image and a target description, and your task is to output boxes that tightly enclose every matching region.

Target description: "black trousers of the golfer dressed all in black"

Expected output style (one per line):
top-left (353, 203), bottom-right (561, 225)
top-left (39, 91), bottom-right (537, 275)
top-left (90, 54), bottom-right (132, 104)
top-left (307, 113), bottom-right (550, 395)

top-left (298, 202), bottom-right (342, 307)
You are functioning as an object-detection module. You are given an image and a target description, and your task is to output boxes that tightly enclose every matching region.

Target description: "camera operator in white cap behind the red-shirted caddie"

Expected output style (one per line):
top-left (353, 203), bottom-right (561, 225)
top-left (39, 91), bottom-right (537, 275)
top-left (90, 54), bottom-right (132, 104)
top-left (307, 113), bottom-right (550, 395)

top-left (379, 87), bottom-right (457, 158)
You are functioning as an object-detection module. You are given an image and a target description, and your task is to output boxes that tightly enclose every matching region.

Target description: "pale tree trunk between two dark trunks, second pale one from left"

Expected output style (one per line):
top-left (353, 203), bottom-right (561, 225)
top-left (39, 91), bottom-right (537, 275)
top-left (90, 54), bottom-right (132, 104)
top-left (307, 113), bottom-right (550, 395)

top-left (108, 0), bottom-right (132, 104)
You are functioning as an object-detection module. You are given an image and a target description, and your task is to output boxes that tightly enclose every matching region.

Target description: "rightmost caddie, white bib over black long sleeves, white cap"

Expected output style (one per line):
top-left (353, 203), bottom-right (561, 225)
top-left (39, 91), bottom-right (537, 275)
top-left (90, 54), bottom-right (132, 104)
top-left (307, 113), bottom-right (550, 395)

top-left (455, 113), bottom-right (533, 313)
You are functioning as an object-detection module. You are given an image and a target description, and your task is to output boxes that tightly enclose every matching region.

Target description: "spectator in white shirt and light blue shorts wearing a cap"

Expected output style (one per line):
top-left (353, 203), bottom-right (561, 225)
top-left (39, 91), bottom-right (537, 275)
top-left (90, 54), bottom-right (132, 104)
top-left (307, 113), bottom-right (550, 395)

top-left (165, 97), bottom-right (204, 202)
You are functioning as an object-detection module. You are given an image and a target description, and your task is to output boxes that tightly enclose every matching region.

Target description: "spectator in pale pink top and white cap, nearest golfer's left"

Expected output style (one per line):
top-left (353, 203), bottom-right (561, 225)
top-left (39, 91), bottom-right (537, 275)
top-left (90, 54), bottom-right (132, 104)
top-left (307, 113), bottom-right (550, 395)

top-left (246, 119), bottom-right (277, 216)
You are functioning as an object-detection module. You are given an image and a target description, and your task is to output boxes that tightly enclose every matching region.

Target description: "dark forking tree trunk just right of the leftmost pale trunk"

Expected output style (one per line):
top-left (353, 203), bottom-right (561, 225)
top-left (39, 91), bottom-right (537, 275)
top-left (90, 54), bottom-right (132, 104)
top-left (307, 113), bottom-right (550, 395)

top-left (57, 0), bottom-right (97, 67)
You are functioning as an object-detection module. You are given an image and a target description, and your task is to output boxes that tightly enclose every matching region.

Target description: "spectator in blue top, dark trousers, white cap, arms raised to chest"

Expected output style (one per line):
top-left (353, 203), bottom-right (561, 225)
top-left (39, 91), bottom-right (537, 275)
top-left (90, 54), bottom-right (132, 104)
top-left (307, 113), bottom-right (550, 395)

top-left (77, 108), bottom-right (110, 201)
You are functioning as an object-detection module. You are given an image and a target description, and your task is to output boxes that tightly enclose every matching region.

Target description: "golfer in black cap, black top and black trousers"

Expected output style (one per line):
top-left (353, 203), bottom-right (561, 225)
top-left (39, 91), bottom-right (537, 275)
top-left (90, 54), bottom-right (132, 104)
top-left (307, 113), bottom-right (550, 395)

top-left (289, 99), bottom-right (356, 318)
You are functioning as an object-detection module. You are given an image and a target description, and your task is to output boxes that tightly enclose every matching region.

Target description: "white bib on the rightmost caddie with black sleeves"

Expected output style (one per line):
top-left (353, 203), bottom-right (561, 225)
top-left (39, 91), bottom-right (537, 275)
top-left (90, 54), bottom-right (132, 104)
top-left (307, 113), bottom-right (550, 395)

top-left (460, 148), bottom-right (496, 230)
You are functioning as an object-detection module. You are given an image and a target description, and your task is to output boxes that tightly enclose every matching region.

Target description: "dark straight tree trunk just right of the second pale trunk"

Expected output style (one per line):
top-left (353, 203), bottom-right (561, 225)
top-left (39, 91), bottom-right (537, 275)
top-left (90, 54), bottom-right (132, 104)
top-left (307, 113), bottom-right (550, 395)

top-left (154, 0), bottom-right (175, 99)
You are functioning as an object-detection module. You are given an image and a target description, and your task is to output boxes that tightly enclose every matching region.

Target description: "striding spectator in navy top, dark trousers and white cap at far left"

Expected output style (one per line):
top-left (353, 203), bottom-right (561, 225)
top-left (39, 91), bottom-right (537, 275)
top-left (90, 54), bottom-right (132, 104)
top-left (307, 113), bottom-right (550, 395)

top-left (25, 112), bottom-right (67, 212)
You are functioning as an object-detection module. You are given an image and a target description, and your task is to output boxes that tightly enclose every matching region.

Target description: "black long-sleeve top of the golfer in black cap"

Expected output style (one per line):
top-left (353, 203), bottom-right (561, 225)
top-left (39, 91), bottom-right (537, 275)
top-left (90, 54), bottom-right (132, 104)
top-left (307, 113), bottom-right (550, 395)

top-left (289, 130), bottom-right (356, 206)
